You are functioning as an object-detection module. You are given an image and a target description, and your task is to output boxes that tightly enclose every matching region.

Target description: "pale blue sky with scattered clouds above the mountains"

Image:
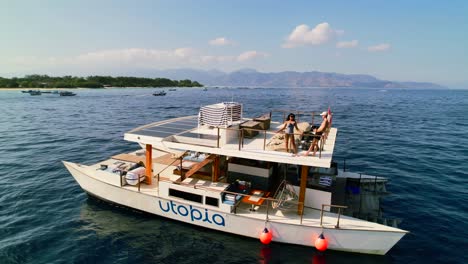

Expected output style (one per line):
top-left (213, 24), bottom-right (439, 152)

top-left (0, 0), bottom-right (468, 87)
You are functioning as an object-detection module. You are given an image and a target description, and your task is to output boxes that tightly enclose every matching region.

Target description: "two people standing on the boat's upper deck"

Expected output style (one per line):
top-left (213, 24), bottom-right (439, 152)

top-left (276, 112), bottom-right (328, 156)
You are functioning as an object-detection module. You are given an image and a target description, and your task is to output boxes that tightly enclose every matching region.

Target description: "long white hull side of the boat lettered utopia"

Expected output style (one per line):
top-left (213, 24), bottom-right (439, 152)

top-left (64, 162), bottom-right (406, 255)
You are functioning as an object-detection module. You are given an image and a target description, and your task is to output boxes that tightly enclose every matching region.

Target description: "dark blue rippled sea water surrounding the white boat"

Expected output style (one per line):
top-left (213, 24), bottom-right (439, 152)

top-left (0, 88), bottom-right (468, 263)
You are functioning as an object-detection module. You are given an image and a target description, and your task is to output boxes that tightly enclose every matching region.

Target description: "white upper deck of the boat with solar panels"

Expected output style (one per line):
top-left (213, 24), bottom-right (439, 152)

top-left (124, 116), bottom-right (337, 168)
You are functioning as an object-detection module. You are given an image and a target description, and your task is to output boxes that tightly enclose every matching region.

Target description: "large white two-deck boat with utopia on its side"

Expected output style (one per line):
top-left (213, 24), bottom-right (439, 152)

top-left (64, 102), bottom-right (407, 255)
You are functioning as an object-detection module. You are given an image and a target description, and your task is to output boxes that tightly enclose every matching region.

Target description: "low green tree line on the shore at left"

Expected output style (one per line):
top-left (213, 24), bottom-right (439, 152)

top-left (0, 74), bottom-right (203, 88)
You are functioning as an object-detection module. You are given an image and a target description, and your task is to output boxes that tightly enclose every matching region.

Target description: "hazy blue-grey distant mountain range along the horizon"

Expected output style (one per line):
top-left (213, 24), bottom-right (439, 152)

top-left (148, 69), bottom-right (445, 88)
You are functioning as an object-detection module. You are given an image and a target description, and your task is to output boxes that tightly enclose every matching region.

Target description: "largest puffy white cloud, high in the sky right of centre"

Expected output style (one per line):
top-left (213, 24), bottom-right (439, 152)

top-left (282, 22), bottom-right (343, 48)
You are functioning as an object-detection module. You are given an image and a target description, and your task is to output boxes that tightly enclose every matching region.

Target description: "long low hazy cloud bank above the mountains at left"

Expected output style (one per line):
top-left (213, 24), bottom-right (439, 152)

top-left (5, 47), bottom-right (269, 74)
